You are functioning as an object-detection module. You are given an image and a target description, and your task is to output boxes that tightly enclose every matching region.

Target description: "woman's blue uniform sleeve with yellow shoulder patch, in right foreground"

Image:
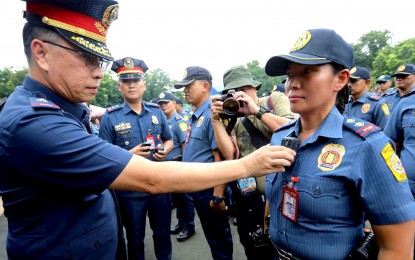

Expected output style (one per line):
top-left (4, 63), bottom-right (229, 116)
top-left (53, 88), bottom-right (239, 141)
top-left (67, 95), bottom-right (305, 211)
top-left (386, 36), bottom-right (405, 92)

top-left (359, 132), bottom-right (415, 225)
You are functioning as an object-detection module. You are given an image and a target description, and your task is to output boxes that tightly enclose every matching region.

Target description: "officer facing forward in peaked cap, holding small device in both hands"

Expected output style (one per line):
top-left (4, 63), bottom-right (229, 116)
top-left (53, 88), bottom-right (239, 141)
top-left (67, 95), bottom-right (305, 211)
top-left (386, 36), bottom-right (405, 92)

top-left (99, 57), bottom-right (173, 259)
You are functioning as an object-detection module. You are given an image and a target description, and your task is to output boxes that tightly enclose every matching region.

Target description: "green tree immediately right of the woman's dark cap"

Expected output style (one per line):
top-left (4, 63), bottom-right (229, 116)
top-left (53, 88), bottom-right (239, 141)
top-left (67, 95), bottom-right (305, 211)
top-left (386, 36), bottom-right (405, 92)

top-left (352, 30), bottom-right (392, 70)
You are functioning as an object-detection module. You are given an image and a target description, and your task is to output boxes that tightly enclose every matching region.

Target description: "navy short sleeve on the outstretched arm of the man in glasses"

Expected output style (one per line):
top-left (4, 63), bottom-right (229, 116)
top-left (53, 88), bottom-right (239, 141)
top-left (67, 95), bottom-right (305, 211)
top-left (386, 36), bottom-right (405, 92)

top-left (10, 111), bottom-right (132, 193)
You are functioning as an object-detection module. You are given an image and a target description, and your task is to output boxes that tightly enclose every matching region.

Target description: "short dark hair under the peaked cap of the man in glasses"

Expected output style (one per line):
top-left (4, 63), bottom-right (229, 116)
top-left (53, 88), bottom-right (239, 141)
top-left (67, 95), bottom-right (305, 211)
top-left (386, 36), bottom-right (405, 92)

top-left (23, 23), bottom-right (62, 62)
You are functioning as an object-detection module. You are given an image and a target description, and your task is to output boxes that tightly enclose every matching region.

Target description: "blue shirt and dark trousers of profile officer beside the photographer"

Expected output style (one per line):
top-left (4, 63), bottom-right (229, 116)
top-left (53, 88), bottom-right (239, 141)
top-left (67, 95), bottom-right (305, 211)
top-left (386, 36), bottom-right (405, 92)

top-left (183, 99), bottom-right (233, 259)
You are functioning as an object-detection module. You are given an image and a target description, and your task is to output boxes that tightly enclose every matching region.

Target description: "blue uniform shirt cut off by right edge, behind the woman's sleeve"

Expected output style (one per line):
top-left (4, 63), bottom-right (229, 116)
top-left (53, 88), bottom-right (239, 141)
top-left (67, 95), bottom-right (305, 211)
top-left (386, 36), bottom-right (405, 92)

top-left (384, 88), bottom-right (415, 196)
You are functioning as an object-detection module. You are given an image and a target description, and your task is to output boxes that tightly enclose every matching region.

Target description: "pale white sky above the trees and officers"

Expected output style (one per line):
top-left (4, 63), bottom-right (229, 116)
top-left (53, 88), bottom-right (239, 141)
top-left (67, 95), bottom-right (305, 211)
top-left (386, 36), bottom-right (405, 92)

top-left (0, 0), bottom-right (415, 86)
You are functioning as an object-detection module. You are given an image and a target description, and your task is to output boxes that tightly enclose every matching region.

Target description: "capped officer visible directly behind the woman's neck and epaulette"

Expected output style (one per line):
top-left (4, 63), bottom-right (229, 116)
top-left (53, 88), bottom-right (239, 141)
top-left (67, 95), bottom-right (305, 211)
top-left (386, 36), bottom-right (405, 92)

top-left (344, 66), bottom-right (389, 129)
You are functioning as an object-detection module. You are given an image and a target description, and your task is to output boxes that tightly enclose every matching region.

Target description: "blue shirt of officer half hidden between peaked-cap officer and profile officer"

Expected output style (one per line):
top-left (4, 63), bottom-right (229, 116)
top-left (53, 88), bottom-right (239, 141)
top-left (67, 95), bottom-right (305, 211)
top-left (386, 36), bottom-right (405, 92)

top-left (166, 113), bottom-right (187, 161)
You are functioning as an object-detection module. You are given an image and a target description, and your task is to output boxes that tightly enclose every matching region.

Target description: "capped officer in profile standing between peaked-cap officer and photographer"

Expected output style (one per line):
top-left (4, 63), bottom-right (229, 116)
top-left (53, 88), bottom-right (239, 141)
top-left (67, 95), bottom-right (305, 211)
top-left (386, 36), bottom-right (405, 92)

top-left (174, 66), bottom-right (233, 259)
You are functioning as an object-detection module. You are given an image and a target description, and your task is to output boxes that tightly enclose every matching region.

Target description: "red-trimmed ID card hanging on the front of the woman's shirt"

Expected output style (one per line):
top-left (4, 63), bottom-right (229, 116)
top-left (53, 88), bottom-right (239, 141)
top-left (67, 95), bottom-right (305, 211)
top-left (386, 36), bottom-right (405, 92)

top-left (282, 176), bottom-right (299, 222)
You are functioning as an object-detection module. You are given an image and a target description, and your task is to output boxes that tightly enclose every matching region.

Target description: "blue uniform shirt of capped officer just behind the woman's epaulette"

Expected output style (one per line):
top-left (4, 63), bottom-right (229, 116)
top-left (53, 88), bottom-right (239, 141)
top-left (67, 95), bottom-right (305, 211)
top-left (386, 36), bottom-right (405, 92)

top-left (344, 92), bottom-right (390, 129)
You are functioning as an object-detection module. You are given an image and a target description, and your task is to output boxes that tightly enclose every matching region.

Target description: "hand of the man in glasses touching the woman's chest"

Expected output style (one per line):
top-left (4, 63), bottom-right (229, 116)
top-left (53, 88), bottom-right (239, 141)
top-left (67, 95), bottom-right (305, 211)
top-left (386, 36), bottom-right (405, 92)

top-left (239, 145), bottom-right (296, 177)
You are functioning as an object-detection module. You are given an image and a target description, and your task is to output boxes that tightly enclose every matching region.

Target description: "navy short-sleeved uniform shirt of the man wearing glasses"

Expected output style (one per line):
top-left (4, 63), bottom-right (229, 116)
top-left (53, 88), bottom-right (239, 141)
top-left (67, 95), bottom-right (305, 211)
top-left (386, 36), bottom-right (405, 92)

top-left (0, 76), bottom-right (132, 259)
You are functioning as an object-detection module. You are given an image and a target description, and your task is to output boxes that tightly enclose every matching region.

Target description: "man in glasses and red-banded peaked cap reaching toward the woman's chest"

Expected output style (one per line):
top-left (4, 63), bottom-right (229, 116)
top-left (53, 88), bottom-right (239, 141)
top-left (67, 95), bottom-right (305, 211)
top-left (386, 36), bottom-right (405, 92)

top-left (0, 0), bottom-right (294, 259)
